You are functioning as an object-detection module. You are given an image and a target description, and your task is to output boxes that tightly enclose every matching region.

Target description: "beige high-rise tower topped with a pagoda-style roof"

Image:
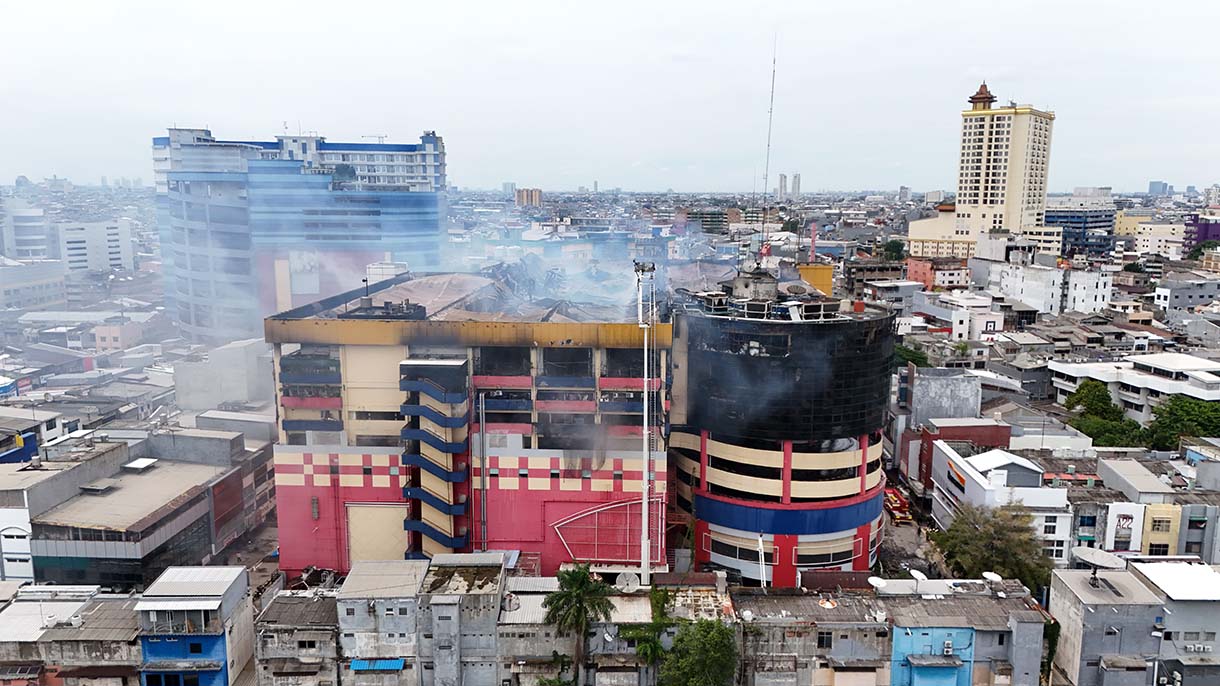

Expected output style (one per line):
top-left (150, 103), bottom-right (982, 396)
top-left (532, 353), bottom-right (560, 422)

top-left (954, 83), bottom-right (1055, 238)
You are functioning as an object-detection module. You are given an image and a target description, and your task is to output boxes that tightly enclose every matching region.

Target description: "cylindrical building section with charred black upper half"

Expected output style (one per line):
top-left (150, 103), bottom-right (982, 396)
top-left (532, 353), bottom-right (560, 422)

top-left (670, 271), bottom-right (893, 586)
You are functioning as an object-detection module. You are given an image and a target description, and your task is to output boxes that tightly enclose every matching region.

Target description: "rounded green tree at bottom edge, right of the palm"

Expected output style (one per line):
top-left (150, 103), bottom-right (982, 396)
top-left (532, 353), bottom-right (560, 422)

top-left (660, 619), bottom-right (737, 686)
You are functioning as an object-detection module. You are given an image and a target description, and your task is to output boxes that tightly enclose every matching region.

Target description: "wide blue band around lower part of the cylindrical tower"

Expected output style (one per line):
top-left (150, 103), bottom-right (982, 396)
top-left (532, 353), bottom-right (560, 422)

top-left (694, 491), bottom-right (885, 536)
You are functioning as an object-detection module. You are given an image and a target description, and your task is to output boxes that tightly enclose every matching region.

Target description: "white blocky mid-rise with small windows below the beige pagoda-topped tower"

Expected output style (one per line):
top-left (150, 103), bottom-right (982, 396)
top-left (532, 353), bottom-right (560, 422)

top-left (988, 264), bottom-right (1114, 315)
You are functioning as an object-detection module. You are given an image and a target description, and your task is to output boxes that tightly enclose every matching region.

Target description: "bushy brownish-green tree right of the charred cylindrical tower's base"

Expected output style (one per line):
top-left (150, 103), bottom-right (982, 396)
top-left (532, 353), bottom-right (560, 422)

top-left (932, 505), bottom-right (1054, 592)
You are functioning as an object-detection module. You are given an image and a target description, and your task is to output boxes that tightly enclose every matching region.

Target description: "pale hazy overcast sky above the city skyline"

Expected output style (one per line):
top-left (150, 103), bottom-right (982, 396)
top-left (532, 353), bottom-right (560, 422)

top-left (0, 0), bottom-right (1220, 190)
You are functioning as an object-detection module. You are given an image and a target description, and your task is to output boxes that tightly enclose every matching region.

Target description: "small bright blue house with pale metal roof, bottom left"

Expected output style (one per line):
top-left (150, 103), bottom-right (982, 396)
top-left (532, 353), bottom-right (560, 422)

top-left (135, 566), bottom-right (254, 686)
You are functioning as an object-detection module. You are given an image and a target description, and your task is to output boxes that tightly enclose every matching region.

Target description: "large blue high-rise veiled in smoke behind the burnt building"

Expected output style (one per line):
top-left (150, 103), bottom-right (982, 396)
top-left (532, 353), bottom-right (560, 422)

top-left (153, 128), bottom-right (448, 342)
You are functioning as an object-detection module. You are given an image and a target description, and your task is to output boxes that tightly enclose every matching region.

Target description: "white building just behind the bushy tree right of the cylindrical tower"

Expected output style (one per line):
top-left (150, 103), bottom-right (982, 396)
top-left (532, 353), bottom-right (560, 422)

top-left (932, 441), bottom-right (1072, 565)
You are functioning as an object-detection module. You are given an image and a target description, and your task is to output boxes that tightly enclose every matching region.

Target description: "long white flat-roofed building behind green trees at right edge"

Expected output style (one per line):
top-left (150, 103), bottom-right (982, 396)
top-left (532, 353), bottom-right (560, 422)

top-left (1048, 353), bottom-right (1220, 425)
